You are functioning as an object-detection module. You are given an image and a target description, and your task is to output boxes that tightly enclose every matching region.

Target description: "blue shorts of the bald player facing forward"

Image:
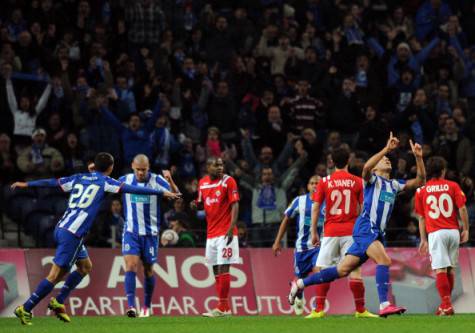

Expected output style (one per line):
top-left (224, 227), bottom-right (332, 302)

top-left (122, 231), bottom-right (158, 264)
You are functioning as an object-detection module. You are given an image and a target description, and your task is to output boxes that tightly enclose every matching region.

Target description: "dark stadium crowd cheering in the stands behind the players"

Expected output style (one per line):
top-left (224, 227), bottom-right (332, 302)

top-left (0, 0), bottom-right (475, 246)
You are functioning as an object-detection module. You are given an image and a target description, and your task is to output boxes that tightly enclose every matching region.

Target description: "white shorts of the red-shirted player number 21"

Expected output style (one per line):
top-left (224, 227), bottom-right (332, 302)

top-left (316, 236), bottom-right (353, 267)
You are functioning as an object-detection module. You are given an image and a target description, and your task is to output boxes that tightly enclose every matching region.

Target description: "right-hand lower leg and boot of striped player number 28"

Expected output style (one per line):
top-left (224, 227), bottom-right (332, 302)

top-left (48, 257), bottom-right (92, 323)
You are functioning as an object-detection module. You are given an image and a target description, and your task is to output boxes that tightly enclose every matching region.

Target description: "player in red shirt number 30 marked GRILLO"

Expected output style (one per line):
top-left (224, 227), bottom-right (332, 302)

top-left (414, 156), bottom-right (468, 316)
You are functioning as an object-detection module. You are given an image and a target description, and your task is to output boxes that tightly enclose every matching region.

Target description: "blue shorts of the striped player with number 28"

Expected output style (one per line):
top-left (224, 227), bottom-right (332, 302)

top-left (53, 228), bottom-right (89, 269)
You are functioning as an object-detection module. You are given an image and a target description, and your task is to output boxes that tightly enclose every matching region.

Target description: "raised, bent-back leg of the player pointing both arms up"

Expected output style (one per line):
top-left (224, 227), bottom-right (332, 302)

top-left (288, 255), bottom-right (360, 305)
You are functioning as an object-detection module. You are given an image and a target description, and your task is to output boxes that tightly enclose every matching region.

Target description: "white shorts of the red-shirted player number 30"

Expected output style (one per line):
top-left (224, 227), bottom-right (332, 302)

top-left (429, 229), bottom-right (460, 269)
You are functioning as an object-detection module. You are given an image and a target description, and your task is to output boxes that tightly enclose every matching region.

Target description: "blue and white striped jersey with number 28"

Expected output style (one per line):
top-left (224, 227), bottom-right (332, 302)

top-left (58, 172), bottom-right (121, 237)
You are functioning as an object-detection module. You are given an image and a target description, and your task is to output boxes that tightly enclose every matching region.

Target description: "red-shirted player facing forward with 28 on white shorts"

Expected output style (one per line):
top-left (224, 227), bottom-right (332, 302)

top-left (191, 157), bottom-right (239, 317)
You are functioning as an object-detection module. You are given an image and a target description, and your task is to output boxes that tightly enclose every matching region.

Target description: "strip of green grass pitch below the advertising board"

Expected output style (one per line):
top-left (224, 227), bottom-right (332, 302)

top-left (0, 314), bottom-right (475, 333)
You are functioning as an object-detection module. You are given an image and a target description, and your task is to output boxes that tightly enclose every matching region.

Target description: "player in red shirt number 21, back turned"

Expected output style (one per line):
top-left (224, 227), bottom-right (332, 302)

top-left (311, 148), bottom-right (378, 318)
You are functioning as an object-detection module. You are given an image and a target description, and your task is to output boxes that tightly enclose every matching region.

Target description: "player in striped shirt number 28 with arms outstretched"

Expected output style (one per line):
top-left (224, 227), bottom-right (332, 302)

top-left (12, 153), bottom-right (179, 325)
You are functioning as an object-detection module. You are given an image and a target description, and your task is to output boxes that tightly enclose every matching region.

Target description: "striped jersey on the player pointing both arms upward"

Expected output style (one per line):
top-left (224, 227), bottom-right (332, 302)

top-left (359, 174), bottom-right (406, 232)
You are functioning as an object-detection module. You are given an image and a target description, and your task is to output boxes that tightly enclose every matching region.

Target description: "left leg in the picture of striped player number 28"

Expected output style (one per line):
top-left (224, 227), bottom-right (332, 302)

top-left (14, 263), bottom-right (68, 326)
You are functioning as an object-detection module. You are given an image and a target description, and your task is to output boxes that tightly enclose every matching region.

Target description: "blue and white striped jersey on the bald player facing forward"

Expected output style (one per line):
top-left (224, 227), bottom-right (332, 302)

top-left (119, 173), bottom-right (171, 236)
